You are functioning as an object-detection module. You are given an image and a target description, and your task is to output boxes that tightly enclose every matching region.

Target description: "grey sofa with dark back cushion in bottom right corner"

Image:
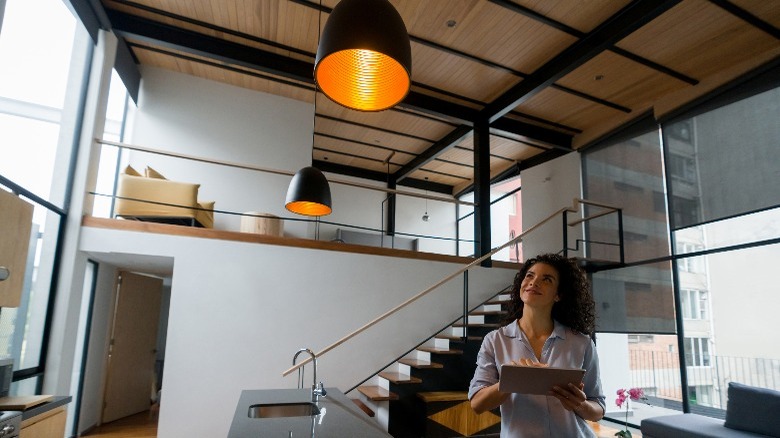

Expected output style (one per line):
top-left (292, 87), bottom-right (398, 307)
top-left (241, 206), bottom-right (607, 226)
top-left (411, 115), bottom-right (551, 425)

top-left (641, 382), bottom-right (780, 438)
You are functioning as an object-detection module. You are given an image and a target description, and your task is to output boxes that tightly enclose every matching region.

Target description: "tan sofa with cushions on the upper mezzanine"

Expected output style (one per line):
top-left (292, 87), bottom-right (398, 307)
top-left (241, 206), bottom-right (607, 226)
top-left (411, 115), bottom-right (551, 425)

top-left (114, 166), bottom-right (214, 228)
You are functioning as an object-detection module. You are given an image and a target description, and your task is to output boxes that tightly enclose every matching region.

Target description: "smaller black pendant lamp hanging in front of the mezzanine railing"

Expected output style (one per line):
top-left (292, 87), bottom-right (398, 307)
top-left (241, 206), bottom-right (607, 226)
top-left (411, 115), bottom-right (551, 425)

top-left (284, 166), bottom-right (333, 216)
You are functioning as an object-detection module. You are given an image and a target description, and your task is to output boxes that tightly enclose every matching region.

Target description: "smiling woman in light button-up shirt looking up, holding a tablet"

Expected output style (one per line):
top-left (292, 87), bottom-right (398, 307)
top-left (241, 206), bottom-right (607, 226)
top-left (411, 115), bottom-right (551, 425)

top-left (469, 254), bottom-right (605, 437)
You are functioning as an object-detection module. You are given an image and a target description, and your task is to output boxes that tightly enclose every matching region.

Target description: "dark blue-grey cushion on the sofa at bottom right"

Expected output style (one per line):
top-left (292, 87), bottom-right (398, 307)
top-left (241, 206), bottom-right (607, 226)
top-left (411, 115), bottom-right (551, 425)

top-left (724, 382), bottom-right (780, 437)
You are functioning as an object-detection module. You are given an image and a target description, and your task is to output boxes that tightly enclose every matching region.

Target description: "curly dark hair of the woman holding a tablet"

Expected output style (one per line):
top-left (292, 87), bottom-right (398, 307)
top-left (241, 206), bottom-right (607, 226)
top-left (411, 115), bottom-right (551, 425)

top-left (504, 254), bottom-right (596, 336)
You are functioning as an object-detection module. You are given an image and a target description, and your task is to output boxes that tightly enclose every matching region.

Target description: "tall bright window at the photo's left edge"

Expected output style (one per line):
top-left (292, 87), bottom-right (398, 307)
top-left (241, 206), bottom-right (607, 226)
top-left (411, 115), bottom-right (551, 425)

top-left (0, 0), bottom-right (91, 394)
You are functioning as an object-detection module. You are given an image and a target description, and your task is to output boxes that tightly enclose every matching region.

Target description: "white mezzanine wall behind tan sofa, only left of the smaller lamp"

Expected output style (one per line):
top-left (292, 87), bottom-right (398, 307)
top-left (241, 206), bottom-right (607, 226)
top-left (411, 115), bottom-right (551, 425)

top-left (129, 68), bottom-right (313, 237)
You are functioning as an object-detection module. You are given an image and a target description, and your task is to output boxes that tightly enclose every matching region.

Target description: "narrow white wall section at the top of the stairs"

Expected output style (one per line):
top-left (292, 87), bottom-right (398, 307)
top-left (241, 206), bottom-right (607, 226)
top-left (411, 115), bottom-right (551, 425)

top-left (521, 153), bottom-right (582, 258)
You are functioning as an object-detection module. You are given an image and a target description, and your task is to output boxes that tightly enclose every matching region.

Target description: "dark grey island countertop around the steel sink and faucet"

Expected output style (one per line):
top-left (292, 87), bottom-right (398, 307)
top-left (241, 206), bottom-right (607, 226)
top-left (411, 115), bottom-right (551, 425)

top-left (228, 388), bottom-right (390, 438)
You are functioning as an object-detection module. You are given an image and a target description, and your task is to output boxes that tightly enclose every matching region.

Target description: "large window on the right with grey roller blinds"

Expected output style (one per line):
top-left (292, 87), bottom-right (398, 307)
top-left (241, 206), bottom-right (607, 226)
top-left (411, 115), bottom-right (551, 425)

top-left (583, 79), bottom-right (780, 425)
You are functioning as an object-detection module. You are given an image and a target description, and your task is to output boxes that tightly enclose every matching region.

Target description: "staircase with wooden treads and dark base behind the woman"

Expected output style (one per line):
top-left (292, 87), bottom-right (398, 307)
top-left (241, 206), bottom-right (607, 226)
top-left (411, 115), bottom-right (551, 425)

top-left (353, 288), bottom-right (509, 438)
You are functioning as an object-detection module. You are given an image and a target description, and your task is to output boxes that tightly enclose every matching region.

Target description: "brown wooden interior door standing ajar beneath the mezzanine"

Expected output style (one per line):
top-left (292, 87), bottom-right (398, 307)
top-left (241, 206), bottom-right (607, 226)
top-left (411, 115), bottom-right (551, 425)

top-left (101, 272), bottom-right (163, 423)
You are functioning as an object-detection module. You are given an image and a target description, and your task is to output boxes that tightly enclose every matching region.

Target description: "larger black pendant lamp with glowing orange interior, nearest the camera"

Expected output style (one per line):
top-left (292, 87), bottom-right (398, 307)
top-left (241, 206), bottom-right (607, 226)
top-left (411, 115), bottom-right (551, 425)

top-left (314, 0), bottom-right (412, 111)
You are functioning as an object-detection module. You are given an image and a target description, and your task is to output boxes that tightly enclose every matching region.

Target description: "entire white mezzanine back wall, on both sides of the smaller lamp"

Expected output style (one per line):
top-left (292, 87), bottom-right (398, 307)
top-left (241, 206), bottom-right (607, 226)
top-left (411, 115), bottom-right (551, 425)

top-left (123, 68), bottom-right (455, 246)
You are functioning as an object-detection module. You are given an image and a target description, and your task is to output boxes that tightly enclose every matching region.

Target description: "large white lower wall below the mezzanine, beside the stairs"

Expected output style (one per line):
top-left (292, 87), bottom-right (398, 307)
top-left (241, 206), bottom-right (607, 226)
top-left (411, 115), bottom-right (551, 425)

top-left (81, 224), bottom-right (515, 438)
